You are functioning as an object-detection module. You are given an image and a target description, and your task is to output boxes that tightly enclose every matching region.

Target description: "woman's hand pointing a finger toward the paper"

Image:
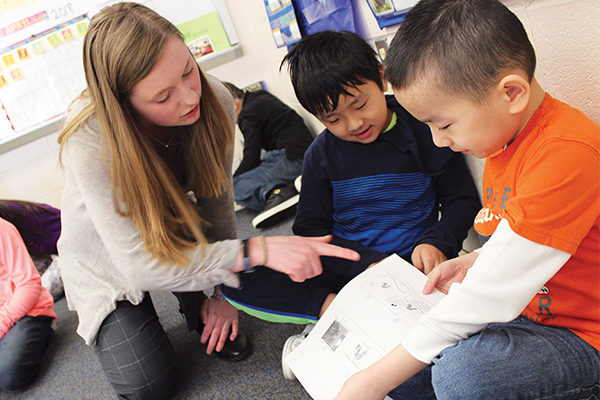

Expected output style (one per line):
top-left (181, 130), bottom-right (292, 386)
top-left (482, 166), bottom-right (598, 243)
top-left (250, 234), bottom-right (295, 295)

top-left (253, 235), bottom-right (360, 282)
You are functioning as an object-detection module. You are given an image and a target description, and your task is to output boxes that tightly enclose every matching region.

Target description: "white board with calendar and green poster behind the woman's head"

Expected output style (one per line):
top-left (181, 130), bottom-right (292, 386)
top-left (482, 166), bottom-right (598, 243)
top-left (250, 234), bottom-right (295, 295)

top-left (0, 0), bottom-right (242, 153)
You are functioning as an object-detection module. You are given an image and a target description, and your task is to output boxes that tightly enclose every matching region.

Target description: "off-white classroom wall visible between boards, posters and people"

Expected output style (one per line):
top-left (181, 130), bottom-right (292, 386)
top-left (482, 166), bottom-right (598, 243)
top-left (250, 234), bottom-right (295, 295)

top-left (0, 0), bottom-right (600, 206)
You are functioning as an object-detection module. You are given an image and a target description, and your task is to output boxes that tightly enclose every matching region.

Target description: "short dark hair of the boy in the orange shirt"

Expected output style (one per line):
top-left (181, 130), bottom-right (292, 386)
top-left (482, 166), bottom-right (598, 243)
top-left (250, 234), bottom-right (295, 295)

top-left (384, 0), bottom-right (536, 102)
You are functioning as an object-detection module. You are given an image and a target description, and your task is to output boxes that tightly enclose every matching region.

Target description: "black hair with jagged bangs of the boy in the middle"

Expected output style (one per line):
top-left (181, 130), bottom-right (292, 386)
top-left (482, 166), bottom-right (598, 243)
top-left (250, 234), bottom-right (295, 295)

top-left (280, 31), bottom-right (383, 116)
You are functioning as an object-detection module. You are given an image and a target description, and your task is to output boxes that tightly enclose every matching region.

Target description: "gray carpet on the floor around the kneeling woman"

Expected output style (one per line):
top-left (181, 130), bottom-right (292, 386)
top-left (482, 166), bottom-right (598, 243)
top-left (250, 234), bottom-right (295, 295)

top-left (0, 210), bottom-right (310, 400)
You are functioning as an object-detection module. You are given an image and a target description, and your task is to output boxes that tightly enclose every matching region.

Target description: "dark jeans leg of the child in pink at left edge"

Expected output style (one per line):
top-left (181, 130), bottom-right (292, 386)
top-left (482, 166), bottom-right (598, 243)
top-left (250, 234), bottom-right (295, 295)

top-left (0, 316), bottom-right (53, 390)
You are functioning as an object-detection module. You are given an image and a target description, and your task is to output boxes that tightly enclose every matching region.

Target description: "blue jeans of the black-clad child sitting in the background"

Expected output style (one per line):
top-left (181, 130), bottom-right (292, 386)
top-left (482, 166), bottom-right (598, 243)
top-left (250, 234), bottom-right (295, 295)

top-left (233, 149), bottom-right (302, 211)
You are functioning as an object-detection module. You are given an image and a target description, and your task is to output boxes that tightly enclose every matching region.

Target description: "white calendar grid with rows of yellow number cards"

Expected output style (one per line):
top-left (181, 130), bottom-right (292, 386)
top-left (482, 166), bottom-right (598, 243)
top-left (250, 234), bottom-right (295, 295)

top-left (0, 15), bottom-right (89, 143)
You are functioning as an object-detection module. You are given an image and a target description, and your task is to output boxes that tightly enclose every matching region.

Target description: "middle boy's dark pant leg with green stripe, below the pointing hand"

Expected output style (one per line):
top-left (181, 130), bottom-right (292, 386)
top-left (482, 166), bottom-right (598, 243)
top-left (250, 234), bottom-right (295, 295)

top-left (221, 266), bottom-right (348, 324)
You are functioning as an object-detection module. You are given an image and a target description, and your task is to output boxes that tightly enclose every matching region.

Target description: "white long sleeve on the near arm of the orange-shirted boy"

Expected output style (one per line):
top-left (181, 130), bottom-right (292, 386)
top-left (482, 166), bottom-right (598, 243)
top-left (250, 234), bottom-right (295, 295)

top-left (402, 220), bottom-right (571, 363)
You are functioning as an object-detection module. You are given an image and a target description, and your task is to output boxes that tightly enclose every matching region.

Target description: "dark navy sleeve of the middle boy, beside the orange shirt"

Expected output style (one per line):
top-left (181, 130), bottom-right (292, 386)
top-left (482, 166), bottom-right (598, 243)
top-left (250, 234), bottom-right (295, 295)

top-left (415, 154), bottom-right (481, 258)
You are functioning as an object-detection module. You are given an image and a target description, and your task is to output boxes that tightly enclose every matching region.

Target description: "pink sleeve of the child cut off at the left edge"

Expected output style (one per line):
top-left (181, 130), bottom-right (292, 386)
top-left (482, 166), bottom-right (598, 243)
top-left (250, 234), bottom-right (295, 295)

top-left (0, 219), bottom-right (42, 338)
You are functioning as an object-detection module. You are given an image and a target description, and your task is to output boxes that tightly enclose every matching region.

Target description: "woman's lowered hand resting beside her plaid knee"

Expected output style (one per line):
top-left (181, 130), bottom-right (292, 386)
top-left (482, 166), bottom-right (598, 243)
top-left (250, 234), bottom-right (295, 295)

top-left (200, 297), bottom-right (238, 354)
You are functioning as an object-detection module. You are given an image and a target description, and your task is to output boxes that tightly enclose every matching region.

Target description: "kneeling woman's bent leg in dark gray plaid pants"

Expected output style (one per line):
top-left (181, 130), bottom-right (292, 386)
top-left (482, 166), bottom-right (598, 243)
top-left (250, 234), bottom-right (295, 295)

top-left (95, 295), bottom-right (176, 400)
